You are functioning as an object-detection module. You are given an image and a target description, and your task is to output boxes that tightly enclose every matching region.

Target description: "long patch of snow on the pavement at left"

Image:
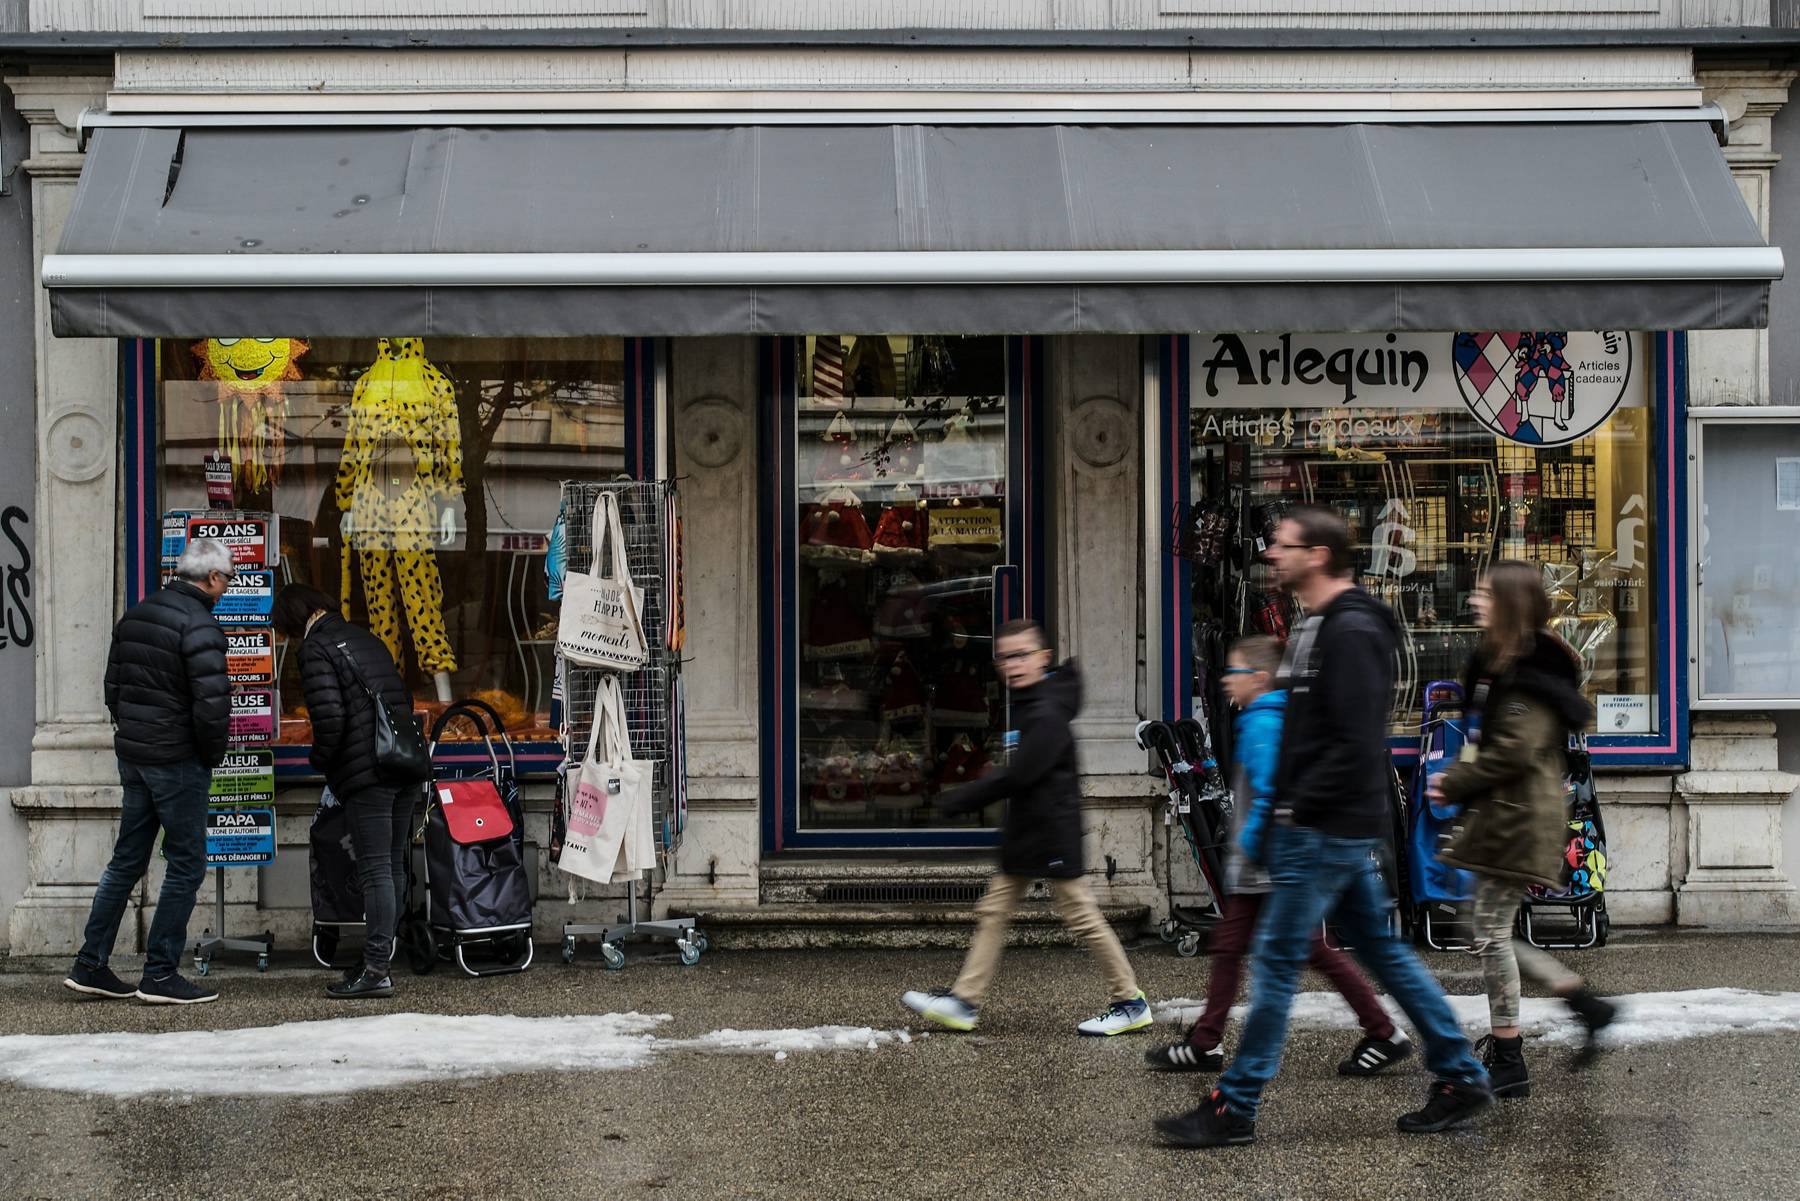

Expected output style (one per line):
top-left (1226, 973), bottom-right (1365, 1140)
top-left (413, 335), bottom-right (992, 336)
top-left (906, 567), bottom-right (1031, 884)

top-left (0, 1012), bottom-right (896, 1104)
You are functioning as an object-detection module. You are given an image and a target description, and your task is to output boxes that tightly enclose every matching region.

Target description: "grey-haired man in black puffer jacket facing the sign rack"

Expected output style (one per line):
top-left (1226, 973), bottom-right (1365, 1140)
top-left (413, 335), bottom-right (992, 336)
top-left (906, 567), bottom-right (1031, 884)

top-left (63, 538), bottom-right (232, 1005)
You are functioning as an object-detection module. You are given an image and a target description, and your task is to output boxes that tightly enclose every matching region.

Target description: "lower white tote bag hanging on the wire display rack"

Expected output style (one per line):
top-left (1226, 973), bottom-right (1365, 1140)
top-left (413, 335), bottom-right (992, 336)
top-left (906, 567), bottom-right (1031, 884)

top-left (556, 675), bottom-right (657, 884)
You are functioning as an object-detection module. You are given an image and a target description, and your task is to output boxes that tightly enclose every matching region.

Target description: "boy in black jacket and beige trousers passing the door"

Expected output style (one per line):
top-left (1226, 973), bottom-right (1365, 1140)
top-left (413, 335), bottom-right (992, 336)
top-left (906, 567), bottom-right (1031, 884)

top-left (900, 621), bottom-right (1150, 1035)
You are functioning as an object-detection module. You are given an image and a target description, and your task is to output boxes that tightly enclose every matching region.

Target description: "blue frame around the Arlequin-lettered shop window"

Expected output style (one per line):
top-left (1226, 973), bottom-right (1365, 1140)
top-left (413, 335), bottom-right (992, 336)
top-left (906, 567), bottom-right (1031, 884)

top-left (1150, 331), bottom-right (1688, 767)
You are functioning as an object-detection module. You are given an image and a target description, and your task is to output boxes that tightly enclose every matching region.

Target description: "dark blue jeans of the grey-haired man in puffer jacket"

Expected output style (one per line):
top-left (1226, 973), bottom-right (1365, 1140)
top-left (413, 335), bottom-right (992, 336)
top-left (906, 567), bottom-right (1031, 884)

top-left (76, 760), bottom-right (212, 980)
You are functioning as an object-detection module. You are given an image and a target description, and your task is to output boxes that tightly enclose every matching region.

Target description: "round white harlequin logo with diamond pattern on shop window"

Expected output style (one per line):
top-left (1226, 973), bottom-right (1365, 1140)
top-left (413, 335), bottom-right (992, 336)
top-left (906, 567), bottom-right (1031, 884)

top-left (1451, 330), bottom-right (1633, 447)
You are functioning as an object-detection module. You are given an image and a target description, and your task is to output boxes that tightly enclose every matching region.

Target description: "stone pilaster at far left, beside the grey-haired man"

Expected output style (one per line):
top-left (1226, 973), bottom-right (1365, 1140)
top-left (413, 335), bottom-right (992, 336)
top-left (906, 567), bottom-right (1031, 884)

top-left (5, 74), bottom-right (135, 954)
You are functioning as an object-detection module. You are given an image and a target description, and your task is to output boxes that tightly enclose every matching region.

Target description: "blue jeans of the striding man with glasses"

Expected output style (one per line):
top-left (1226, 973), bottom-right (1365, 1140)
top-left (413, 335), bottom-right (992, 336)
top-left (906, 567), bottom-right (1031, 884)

top-left (1219, 826), bottom-right (1487, 1118)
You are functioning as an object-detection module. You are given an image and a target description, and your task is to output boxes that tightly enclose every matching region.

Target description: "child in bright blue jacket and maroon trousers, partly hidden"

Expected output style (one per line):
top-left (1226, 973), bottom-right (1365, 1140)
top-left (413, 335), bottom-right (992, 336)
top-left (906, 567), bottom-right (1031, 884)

top-left (1145, 637), bottom-right (1413, 1075)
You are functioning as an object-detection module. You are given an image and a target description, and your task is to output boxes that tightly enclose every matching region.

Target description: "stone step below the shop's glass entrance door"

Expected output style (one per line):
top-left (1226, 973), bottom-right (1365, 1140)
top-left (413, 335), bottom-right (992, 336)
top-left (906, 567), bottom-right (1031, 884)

top-left (675, 900), bottom-right (1150, 951)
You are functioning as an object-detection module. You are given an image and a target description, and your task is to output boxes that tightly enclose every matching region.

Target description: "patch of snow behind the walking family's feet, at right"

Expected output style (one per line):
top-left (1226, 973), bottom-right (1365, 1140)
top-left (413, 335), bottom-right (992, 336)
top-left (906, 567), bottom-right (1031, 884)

top-left (1156, 989), bottom-right (1800, 1046)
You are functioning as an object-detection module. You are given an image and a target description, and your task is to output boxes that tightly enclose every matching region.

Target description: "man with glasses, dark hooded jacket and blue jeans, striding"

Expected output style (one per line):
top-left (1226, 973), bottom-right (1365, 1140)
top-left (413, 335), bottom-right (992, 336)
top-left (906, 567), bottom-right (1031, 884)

top-left (1156, 508), bottom-right (1494, 1147)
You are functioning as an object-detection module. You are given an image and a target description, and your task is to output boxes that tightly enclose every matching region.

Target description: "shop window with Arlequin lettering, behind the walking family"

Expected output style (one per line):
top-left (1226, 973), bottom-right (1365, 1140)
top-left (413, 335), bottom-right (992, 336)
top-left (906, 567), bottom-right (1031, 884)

top-left (1179, 331), bottom-right (1663, 735)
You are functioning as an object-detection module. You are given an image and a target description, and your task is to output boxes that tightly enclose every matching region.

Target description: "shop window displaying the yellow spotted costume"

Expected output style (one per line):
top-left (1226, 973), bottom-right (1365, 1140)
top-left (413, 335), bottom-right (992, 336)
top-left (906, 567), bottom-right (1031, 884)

top-left (157, 337), bottom-right (625, 744)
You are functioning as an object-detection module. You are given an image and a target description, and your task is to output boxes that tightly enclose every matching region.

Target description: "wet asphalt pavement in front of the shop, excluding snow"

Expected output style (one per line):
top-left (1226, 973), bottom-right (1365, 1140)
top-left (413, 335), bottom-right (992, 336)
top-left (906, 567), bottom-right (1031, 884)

top-left (0, 931), bottom-right (1800, 1201)
